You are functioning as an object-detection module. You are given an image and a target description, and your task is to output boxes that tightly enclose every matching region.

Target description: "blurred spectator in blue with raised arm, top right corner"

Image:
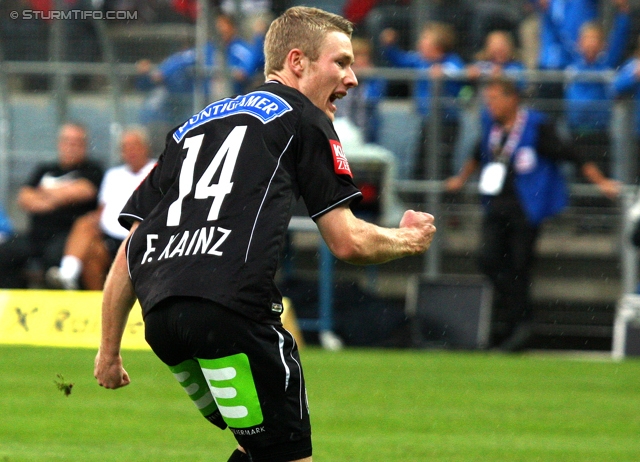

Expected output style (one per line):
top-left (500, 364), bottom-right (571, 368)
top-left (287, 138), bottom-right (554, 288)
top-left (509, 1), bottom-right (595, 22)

top-left (565, 0), bottom-right (630, 132)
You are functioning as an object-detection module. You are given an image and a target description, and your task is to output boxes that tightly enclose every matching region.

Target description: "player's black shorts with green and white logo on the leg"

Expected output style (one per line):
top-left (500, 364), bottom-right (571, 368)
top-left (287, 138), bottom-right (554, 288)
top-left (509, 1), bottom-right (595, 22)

top-left (145, 297), bottom-right (311, 462)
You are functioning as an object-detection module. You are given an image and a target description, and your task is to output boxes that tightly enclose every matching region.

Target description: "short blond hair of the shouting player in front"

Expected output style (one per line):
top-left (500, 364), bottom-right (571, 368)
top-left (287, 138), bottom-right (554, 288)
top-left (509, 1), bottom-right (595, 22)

top-left (264, 6), bottom-right (353, 75)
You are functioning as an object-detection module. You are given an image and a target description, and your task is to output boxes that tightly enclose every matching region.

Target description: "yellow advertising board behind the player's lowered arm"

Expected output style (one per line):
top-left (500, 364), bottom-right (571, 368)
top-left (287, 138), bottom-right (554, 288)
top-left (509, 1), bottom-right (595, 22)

top-left (0, 290), bottom-right (149, 349)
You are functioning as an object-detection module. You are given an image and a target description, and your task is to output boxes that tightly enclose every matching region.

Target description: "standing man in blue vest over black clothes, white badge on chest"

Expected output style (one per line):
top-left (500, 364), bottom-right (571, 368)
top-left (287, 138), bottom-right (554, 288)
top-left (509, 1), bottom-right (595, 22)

top-left (446, 78), bottom-right (620, 351)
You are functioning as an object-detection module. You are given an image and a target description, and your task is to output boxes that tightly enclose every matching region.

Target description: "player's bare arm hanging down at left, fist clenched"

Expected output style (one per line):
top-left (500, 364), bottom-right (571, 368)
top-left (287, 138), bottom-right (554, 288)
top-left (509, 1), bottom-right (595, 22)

top-left (93, 222), bottom-right (139, 389)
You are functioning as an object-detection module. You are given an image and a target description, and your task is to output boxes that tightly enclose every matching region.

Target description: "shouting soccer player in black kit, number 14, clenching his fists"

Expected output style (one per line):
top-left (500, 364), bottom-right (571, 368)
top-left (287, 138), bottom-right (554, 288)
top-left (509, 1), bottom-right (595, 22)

top-left (94, 7), bottom-right (435, 462)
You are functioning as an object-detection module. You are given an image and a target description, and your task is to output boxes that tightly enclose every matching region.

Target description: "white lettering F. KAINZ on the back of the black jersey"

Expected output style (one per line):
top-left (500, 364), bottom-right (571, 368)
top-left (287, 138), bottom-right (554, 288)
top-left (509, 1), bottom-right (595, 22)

top-left (140, 226), bottom-right (231, 265)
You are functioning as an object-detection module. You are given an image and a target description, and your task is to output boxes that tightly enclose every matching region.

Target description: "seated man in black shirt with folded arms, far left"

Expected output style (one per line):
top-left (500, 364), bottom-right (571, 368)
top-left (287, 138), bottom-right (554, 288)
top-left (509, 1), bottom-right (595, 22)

top-left (0, 123), bottom-right (103, 285)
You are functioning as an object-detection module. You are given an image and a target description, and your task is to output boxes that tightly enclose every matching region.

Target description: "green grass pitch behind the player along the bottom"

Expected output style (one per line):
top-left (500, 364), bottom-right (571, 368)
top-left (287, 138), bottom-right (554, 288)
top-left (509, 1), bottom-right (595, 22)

top-left (0, 346), bottom-right (640, 462)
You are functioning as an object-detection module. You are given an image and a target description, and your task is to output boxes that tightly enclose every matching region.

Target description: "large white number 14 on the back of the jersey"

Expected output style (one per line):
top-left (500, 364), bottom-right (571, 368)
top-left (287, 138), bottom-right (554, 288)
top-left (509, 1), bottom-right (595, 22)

top-left (167, 125), bottom-right (247, 226)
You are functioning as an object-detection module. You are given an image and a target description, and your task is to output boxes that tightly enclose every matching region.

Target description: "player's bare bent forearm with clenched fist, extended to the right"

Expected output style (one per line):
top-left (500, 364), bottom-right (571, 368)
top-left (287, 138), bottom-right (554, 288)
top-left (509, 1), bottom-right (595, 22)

top-left (317, 206), bottom-right (436, 265)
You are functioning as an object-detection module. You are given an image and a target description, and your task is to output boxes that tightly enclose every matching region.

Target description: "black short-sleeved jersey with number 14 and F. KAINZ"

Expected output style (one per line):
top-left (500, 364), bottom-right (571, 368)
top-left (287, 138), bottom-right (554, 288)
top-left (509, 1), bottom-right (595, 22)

top-left (120, 82), bottom-right (361, 322)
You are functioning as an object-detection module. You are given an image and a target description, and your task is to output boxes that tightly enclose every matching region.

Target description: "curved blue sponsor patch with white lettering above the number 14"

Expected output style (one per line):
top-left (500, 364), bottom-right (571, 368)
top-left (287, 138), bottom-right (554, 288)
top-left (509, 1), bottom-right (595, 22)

top-left (173, 91), bottom-right (292, 143)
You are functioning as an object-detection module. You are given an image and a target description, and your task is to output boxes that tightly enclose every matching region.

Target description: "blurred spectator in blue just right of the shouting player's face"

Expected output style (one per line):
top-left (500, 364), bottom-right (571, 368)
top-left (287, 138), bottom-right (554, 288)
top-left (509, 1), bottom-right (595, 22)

top-left (336, 37), bottom-right (387, 143)
